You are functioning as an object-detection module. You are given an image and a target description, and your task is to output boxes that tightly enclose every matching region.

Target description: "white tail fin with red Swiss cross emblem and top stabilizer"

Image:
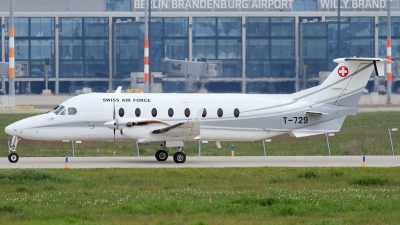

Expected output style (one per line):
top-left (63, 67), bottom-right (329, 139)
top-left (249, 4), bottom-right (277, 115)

top-left (294, 58), bottom-right (387, 107)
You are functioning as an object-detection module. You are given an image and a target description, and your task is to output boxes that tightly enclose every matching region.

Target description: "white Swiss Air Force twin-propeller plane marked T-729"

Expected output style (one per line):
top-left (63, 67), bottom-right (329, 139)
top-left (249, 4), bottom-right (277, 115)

top-left (5, 58), bottom-right (387, 163)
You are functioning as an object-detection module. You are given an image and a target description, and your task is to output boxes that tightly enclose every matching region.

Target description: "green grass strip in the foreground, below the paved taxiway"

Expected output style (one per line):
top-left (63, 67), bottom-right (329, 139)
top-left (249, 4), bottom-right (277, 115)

top-left (0, 167), bottom-right (400, 224)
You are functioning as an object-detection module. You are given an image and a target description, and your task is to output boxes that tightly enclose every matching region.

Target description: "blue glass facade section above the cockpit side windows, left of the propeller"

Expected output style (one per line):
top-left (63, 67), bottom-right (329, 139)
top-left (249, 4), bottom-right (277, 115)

top-left (59, 17), bottom-right (109, 77)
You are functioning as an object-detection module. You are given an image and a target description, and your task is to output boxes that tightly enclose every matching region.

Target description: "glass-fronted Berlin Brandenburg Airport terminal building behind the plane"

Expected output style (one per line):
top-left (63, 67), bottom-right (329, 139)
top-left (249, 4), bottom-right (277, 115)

top-left (0, 0), bottom-right (400, 94)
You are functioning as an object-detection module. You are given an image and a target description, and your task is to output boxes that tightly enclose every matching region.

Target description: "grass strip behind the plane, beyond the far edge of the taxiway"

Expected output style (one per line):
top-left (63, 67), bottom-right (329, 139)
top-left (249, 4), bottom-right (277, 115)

top-left (0, 112), bottom-right (400, 157)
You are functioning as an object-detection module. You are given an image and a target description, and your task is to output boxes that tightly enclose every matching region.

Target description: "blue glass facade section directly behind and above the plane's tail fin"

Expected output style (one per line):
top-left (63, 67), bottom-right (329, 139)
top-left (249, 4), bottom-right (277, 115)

top-left (299, 17), bottom-right (375, 81)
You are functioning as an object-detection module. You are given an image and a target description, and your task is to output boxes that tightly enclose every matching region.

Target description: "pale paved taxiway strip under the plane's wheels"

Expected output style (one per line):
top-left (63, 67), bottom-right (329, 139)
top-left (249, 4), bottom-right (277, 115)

top-left (0, 156), bottom-right (400, 169)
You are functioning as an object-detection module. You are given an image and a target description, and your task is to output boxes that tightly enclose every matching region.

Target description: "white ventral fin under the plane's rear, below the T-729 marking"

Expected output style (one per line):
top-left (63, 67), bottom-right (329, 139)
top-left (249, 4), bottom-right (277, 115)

top-left (290, 116), bottom-right (346, 138)
